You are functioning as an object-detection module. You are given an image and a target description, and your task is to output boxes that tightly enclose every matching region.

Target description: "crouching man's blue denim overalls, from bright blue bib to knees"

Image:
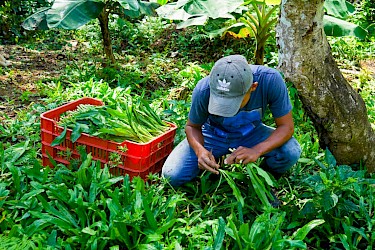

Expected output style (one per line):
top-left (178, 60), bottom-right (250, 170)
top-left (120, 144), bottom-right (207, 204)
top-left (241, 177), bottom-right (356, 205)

top-left (162, 109), bottom-right (301, 186)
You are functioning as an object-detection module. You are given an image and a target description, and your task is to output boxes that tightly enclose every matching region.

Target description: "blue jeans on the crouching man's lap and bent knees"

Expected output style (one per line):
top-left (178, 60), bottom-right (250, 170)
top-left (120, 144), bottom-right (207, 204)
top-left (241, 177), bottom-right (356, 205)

top-left (162, 123), bottom-right (301, 186)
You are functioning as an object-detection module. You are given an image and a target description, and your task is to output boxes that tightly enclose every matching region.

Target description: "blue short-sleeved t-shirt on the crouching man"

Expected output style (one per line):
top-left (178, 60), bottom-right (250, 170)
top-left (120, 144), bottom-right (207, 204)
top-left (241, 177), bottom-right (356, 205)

top-left (189, 65), bottom-right (292, 127)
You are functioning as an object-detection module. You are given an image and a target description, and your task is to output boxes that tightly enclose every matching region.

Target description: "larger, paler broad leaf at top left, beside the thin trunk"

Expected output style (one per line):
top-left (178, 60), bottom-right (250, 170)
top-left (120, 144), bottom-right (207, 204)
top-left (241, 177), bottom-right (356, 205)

top-left (47, 0), bottom-right (105, 29)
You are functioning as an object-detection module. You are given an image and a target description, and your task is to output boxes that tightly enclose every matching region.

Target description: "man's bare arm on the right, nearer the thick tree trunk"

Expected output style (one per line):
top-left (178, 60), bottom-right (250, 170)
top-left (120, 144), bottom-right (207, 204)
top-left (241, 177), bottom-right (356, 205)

top-left (226, 111), bottom-right (294, 164)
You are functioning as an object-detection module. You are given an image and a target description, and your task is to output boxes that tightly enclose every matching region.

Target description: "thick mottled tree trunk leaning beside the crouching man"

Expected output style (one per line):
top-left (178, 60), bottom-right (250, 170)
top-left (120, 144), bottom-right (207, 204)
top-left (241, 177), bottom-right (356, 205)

top-left (276, 0), bottom-right (375, 172)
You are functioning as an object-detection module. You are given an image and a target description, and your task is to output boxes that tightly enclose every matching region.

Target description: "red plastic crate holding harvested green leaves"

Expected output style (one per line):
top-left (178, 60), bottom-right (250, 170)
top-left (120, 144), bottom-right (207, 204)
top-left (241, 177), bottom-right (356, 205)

top-left (41, 97), bottom-right (177, 179)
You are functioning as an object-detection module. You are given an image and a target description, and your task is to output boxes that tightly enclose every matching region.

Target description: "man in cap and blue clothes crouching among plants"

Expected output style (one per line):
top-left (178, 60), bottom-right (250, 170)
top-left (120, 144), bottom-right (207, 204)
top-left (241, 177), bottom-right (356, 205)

top-left (162, 55), bottom-right (301, 186)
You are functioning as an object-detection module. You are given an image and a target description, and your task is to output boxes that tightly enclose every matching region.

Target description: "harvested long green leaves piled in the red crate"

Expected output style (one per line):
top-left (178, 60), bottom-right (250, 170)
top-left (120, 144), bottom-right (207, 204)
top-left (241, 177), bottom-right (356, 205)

top-left (52, 96), bottom-right (170, 145)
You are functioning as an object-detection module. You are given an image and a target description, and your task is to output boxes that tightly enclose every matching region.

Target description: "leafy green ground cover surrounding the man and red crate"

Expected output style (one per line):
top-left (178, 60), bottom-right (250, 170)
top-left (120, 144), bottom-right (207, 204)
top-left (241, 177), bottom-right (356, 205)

top-left (0, 15), bottom-right (375, 249)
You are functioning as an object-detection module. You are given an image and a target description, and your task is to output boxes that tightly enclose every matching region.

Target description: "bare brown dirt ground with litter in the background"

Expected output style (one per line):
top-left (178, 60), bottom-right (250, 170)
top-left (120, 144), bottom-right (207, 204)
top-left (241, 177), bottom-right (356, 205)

top-left (0, 44), bottom-right (375, 121)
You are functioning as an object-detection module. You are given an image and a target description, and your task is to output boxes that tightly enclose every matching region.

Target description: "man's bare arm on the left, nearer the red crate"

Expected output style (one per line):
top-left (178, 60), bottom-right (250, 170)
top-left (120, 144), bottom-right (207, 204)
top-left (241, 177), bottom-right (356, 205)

top-left (185, 120), bottom-right (219, 174)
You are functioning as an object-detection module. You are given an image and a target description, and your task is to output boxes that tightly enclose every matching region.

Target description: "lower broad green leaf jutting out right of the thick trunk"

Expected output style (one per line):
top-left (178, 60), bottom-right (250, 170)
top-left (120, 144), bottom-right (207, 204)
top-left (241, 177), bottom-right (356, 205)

top-left (323, 15), bottom-right (367, 39)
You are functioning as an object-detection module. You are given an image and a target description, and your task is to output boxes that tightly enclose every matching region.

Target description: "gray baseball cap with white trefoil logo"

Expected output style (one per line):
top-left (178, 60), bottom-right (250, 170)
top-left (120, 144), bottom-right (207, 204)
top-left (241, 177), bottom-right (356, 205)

top-left (208, 55), bottom-right (253, 117)
